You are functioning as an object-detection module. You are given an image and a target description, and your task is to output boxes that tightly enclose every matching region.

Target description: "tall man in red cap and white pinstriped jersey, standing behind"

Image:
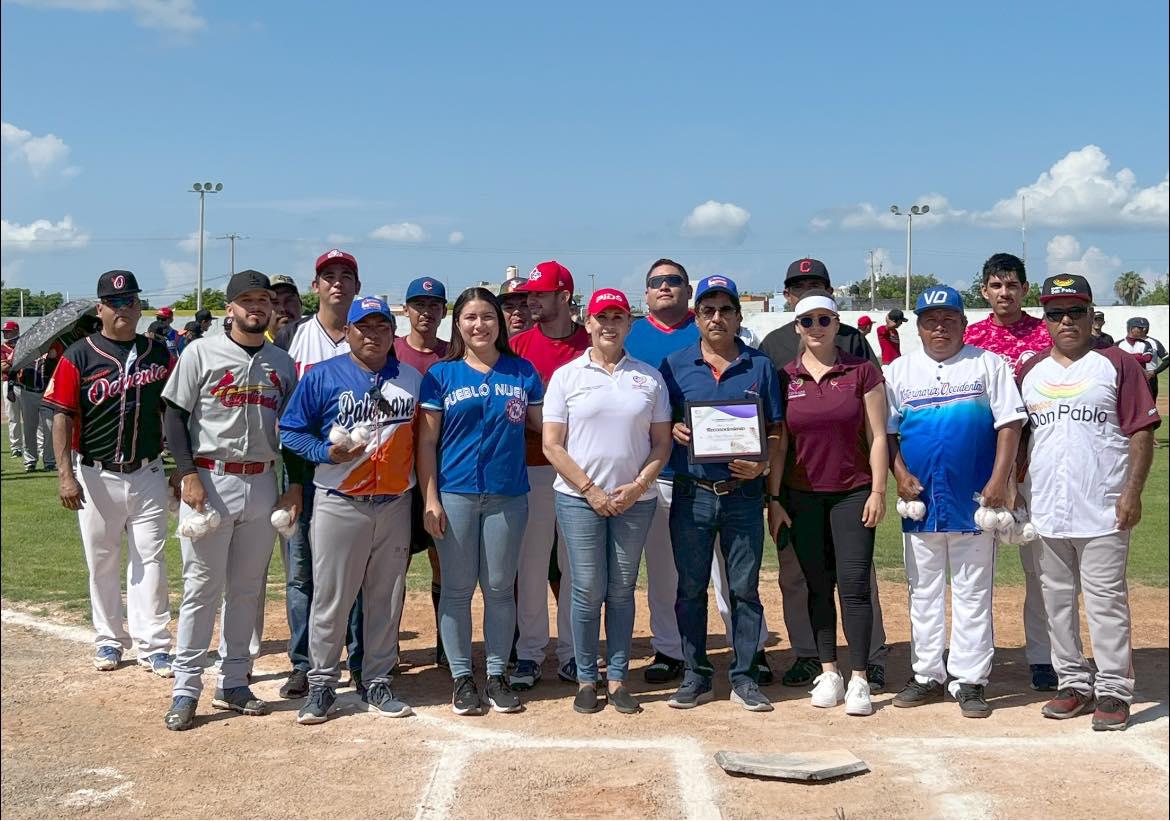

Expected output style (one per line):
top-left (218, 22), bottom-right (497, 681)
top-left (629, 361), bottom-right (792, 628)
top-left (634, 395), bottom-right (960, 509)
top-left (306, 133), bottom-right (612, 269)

top-left (276, 248), bottom-right (362, 698)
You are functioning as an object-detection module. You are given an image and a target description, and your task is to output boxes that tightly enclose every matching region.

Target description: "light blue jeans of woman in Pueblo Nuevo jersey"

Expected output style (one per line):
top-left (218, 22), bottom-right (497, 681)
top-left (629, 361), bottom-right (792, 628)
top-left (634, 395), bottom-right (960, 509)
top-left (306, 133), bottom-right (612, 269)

top-left (435, 494), bottom-right (528, 678)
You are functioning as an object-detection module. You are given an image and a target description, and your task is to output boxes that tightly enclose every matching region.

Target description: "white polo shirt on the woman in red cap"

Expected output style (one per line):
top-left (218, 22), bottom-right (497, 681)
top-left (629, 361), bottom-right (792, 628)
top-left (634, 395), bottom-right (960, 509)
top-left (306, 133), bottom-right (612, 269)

top-left (544, 347), bottom-right (670, 501)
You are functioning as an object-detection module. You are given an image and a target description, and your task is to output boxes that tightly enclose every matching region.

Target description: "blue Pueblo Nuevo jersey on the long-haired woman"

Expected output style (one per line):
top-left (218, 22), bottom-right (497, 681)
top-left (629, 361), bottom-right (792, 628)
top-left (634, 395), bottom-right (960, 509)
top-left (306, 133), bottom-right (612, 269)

top-left (420, 354), bottom-right (544, 496)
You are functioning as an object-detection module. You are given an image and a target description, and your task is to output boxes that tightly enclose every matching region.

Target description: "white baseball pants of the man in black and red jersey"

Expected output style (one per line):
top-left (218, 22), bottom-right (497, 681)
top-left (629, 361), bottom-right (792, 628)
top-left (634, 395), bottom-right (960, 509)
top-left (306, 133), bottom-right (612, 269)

top-left (74, 454), bottom-right (171, 656)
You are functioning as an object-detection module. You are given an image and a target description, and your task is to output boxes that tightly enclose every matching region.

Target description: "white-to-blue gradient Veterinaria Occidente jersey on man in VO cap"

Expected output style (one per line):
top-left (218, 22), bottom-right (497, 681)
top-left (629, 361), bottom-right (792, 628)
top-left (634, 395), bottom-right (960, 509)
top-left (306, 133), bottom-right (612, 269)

top-left (886, 345), bottom-right (1027, 533)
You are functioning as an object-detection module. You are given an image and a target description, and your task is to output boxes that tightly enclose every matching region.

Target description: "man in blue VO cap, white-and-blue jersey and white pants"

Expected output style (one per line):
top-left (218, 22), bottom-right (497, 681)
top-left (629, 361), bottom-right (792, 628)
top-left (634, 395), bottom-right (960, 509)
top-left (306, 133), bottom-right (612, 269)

top-left (886, 285), bottom-right (1026, 718)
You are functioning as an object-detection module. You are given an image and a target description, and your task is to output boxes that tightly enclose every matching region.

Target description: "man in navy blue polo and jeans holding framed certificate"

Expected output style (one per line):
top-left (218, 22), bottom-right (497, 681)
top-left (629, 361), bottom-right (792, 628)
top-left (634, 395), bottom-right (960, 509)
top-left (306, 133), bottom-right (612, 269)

top-left (662, 276), bottom-right (784, 712)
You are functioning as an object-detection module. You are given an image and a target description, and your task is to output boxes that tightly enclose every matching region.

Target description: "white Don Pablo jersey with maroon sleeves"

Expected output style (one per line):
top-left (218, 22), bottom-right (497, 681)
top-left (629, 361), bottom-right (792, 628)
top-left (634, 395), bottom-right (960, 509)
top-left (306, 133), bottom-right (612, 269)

top-left (1019, 347), bottom-right (1159, 539)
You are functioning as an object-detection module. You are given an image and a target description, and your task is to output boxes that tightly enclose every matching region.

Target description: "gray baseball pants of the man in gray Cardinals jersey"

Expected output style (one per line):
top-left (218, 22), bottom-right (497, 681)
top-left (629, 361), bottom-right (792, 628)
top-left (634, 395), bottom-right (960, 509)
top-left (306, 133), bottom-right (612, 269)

top-left (172, 468), bottom-right (276, 698)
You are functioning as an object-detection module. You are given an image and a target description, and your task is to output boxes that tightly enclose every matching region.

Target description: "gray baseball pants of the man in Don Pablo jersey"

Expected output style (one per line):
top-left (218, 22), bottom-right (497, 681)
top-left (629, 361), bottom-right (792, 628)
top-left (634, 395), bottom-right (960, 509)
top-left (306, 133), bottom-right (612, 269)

top-left (1040, 531), bottom-right (1134, 704)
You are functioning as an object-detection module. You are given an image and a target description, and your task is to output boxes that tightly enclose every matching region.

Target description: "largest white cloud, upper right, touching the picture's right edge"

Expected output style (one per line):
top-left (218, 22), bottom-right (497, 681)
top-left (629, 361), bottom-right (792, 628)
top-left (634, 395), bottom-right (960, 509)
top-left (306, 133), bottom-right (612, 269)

top-left (975, 145), bottom-right (1170, 230)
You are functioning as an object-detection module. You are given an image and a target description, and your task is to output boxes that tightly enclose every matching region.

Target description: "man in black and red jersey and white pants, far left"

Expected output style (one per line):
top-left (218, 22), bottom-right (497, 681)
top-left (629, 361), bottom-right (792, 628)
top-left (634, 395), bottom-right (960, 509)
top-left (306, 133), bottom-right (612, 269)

top-left (44, 270), bottom-right (174, 677)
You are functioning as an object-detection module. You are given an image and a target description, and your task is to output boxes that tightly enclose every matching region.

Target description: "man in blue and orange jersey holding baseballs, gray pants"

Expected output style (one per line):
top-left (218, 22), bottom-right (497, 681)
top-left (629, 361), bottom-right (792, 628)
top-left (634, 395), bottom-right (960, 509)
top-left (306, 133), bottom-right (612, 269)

top-left (281, 297), bottom-right (422, 724)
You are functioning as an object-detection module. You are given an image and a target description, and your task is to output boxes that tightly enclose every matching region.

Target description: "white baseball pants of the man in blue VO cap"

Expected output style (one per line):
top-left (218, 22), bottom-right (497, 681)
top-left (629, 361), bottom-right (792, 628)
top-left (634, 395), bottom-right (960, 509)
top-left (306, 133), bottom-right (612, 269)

top-left (902, 533), bottom-right (996, 684)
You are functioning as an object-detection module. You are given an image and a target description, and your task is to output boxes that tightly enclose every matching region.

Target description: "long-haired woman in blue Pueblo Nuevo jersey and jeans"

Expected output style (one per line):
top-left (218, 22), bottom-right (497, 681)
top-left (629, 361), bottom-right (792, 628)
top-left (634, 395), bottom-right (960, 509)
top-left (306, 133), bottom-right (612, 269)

top-left (415, 288), bottom-right (544, 716)
